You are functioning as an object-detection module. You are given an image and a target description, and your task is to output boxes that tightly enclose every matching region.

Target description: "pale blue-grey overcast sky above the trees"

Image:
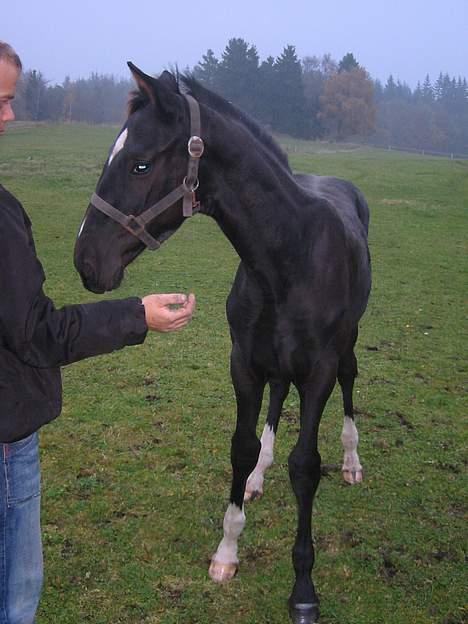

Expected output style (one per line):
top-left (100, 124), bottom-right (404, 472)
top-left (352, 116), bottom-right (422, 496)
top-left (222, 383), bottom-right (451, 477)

top-left (0, 0), bottom-right (468, 87)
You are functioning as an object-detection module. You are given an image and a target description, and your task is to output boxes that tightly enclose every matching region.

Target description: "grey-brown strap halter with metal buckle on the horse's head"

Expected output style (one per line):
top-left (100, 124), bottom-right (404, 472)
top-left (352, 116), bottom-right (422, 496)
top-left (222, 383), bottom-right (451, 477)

top-left (91, 94), bottom-right (204, 251)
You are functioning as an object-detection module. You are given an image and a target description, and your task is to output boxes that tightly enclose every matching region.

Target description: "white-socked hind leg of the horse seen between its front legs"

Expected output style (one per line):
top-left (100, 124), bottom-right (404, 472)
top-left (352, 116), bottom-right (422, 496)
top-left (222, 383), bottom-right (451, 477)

top-left (244, 380), bottom-right (289, 502)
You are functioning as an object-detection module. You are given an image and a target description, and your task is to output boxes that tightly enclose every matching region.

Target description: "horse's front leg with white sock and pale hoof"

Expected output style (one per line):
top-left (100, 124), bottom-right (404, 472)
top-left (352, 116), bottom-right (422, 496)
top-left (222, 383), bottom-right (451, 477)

top-left (209, 347), bottom-right (265, 583)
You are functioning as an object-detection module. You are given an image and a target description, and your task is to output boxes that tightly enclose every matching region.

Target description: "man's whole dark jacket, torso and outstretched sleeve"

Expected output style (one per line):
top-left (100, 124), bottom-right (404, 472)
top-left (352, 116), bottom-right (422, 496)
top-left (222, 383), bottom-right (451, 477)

top-left (0, 185), bottom-right (148, 442)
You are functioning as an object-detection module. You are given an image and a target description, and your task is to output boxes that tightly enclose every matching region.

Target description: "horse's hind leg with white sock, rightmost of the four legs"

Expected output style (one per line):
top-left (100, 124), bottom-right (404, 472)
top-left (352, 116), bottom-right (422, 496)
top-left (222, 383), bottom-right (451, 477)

top-left (338, 329), bottom-right (362, 485)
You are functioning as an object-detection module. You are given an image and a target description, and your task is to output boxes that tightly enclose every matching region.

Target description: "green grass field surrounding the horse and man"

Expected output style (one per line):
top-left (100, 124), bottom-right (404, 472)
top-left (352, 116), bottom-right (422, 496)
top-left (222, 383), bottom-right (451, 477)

top-left (0, 126), bottom-right (468, 624)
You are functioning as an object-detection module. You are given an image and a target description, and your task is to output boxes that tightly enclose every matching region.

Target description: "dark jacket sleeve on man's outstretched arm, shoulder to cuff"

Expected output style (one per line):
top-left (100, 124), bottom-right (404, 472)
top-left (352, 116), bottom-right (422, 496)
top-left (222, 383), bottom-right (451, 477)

top-left (0, 187), bottom-right (148, 368)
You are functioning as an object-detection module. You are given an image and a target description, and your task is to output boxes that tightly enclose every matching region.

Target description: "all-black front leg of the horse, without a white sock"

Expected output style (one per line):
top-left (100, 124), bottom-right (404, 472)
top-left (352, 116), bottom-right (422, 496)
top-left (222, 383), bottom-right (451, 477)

top-left (289, 359), bottom-right (337, 624)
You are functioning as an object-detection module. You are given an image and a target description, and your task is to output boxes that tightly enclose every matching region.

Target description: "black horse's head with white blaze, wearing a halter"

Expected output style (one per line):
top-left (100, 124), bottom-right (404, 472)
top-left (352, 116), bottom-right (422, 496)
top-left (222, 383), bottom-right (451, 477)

top-left (74, 63), bottom-right (199, 293)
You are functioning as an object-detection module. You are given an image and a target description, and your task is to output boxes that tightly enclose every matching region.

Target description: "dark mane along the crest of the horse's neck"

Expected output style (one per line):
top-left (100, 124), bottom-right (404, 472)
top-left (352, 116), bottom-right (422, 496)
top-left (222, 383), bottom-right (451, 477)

top-left (180, 73), bottom-right (289, 170)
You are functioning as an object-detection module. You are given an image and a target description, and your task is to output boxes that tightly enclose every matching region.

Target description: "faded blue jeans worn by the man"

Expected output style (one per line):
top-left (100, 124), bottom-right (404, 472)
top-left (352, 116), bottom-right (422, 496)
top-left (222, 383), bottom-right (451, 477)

top-left (0, 433), bottom-right (43, 624)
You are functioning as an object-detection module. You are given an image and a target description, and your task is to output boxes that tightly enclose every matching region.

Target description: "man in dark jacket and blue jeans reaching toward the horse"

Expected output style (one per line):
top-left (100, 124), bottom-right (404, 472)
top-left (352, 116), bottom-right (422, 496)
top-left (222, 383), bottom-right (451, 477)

top-left (0, 41), bottom-right (195, 624)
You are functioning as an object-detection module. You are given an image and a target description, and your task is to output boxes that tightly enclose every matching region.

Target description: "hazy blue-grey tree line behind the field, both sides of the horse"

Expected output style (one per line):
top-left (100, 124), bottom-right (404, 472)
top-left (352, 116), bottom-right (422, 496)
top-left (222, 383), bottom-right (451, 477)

top-left (11, 38), bottom-right (468, 153)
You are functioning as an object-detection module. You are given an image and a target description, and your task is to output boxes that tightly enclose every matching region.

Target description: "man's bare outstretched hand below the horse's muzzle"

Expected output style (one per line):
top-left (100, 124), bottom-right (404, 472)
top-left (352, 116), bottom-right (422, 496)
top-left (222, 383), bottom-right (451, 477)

top-left (142, 293), bottom-right (195, 332)
